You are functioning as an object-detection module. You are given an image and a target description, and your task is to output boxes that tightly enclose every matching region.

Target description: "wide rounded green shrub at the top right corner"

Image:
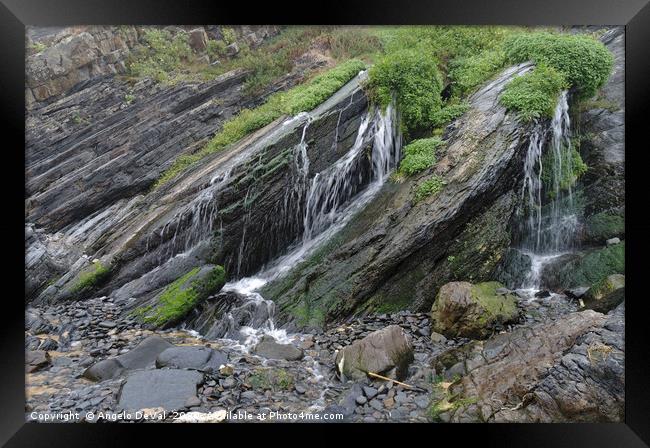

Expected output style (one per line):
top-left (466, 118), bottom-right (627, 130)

top-left (504, 32), bottom-right (614, 98)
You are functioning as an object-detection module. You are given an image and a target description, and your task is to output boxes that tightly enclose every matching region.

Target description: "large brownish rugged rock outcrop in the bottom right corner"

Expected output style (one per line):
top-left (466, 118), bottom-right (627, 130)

top-left (430, 310), bottom-right (623, 422)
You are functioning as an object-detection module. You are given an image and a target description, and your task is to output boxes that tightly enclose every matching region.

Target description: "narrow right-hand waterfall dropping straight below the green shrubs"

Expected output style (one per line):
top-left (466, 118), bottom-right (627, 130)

top-left (521, 91), bottom-right (578, 290)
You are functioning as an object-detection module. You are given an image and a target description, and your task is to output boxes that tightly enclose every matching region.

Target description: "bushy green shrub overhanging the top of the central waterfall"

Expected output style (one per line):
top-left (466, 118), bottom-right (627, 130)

top-left (367, 49), bottom-right (442, 135)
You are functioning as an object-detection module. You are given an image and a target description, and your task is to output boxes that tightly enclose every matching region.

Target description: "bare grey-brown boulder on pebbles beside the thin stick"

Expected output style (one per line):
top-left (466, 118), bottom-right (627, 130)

top-left (336, 325), bottom-right (414, 380)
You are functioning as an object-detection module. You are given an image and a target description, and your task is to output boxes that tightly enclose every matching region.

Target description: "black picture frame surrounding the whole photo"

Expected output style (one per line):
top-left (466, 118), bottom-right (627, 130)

top-left (5, 0), bottom-right (650, 447)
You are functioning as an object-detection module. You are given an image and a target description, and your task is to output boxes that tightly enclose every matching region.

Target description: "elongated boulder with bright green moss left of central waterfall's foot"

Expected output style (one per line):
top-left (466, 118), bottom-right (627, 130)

top-left (133, 265), bottom-right (226, 327)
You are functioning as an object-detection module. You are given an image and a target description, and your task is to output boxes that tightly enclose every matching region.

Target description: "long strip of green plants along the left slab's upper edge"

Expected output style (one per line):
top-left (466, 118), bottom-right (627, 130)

top-left (154, 59), bottom-right (365, 189)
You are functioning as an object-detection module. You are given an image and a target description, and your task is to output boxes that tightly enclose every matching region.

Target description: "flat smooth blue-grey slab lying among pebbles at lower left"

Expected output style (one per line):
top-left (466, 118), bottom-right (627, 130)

top-left (118, 369), bottom-right (203, 410)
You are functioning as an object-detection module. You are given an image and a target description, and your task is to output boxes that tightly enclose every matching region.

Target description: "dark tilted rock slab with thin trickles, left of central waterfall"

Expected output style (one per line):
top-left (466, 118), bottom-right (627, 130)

top-left (26, 75), bottom-right (369, 300)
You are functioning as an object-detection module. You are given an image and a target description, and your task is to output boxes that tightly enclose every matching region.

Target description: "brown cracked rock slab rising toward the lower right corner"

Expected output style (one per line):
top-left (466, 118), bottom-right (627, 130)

top-left (430, 310), bottom-right (622, 423)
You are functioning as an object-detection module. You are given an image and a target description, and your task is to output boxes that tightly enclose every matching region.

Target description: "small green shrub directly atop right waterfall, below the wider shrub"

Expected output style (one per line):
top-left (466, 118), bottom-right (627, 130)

top-left (500, 65), bottom-right (567, 121)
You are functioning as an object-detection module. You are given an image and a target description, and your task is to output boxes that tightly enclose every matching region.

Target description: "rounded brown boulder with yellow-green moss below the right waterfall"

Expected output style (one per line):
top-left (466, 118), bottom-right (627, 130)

top-left (431, 282), bottom-right (519, 339)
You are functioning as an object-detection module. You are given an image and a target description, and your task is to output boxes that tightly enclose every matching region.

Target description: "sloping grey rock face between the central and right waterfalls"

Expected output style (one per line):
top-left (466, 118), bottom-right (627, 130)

top-left (264, 64), bottom-right (530, 320)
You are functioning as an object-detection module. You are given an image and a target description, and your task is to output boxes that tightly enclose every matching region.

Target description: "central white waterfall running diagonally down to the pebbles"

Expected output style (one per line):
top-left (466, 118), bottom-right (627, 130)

top-left (194, 104), bottom-right (401, 348)
